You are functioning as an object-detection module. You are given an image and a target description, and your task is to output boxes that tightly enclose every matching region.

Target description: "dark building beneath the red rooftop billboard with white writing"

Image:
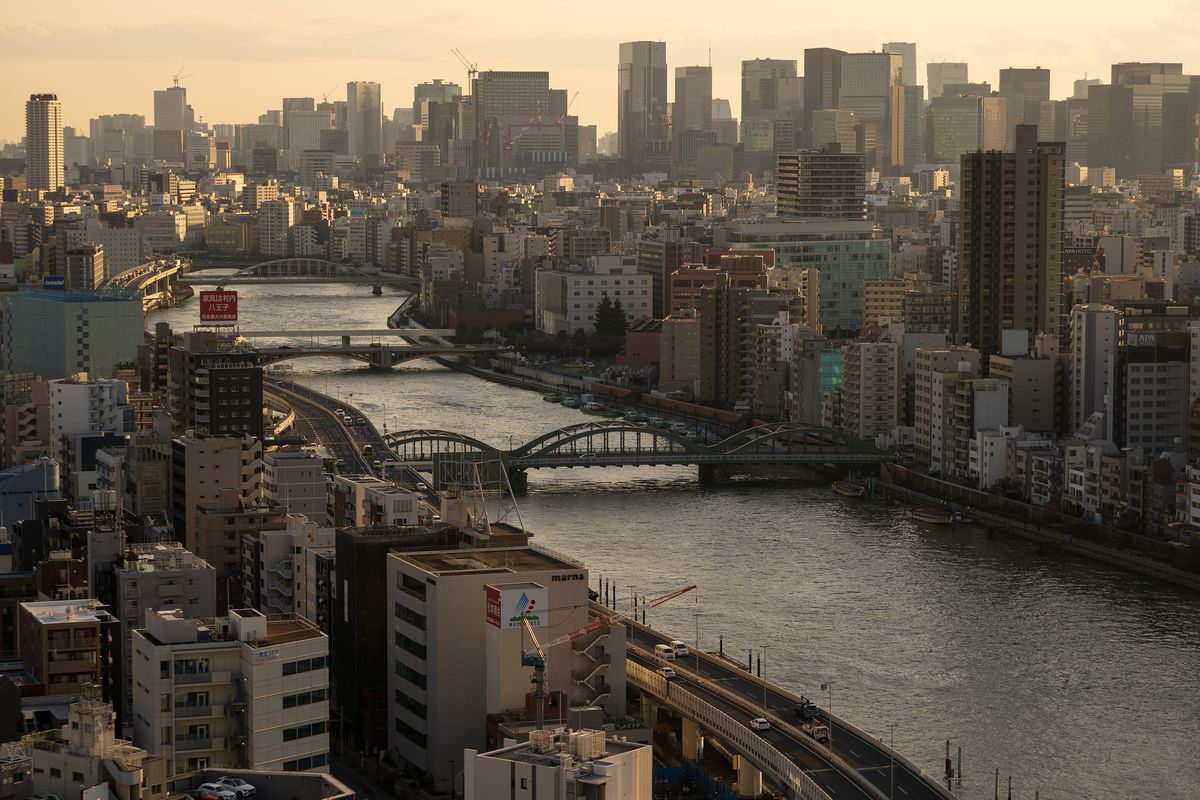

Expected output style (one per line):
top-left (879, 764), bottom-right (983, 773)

top-left (169, 331), bottom-right (263, 438)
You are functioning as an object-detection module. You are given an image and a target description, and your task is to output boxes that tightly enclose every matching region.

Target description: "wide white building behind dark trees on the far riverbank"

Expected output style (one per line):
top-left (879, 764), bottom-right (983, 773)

top-left (535, 255), bottom-right (654, 336)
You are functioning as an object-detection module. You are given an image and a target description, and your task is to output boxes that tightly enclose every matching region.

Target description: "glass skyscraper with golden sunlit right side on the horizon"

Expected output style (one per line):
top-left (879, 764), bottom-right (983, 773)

top-left (838, 53), bottom-right (905, 169)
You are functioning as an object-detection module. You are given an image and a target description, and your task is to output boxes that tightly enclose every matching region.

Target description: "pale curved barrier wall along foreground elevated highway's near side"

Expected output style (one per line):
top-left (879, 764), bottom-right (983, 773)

top-left (625, 661), bottom-right (832, 800)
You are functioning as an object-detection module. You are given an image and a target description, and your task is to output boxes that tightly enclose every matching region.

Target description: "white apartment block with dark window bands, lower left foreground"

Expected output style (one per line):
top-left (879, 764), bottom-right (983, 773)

top-left (133, 608), bottom-right (329, 775)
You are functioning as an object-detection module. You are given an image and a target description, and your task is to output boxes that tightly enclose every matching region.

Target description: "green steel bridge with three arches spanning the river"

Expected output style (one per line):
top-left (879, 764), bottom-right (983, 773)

top-left (386, 420), bottom-right (894, 483)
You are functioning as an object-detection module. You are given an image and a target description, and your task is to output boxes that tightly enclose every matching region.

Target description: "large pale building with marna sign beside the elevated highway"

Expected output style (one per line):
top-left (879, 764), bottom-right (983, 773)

top-left (388, 547), bottom-right (625, 790)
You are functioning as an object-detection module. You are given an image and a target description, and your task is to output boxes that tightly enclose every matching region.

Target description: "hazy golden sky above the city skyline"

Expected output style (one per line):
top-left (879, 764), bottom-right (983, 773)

top-left (0, 0), bottom-right (1200, 139)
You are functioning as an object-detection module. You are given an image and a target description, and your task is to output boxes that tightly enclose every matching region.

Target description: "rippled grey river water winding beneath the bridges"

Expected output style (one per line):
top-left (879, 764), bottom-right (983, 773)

top-left (151, 287), bottom-right (1200, 800)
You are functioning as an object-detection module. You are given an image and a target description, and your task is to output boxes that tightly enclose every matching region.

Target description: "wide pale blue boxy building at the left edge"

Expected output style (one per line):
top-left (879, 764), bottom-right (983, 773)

top-left (0, 287), bottom-right (144, 378)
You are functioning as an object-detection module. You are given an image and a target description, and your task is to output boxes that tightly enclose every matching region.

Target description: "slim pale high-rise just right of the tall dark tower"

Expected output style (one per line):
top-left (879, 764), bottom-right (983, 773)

top-left (1067, 303), bottom-right (1124, 441)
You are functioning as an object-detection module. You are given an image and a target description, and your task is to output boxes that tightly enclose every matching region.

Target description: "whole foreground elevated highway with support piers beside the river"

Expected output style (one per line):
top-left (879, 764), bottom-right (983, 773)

top-left (619, 603), bottom-right (954, 800)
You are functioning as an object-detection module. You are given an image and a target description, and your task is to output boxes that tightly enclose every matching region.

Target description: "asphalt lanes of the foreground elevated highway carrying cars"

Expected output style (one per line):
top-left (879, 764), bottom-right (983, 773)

top-left (626, 626), bottom-right (947, 800)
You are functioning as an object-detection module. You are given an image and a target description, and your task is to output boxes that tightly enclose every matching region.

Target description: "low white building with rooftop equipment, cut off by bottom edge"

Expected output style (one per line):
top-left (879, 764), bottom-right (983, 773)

top-left (463, 722), bottom-right (652, 800)
